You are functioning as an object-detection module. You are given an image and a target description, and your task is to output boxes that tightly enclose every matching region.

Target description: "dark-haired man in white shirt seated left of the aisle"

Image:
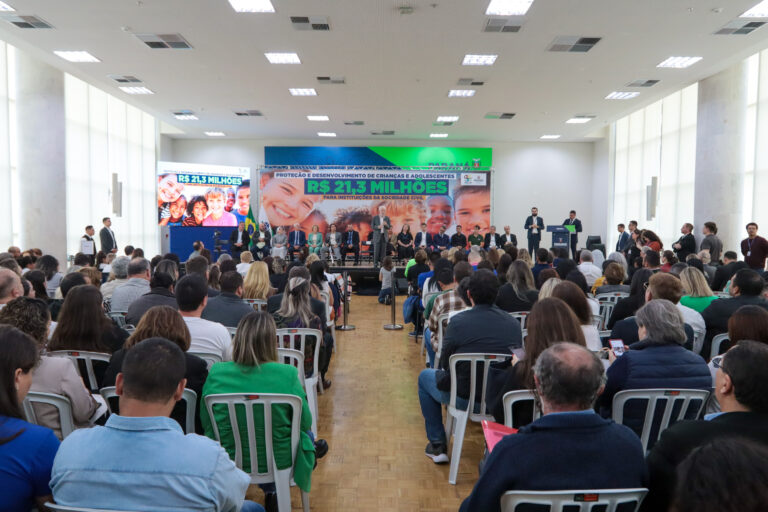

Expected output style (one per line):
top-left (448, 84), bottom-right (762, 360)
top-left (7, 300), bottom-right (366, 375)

top-left (174, 274), bottom-right (232, 361)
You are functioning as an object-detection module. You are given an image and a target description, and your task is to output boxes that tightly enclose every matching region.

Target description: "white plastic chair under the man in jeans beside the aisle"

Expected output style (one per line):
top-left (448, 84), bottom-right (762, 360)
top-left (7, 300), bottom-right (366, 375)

top-left (445, 353), bottom-right (512, 485)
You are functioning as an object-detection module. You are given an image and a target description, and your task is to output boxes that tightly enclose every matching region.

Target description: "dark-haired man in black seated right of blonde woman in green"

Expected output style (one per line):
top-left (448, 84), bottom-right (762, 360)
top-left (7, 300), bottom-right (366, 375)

top-left (701, 268), bottom-right (768, 354)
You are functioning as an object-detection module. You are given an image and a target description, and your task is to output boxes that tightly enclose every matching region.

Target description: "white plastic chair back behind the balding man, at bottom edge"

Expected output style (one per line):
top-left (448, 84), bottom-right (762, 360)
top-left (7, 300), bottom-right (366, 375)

top-left (501, 489), bottom-right (648, 512)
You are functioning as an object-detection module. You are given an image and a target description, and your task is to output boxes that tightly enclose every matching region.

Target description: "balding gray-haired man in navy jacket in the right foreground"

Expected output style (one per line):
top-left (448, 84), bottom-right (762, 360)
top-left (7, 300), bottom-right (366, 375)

top-left (459, 343), bottom-right (647, 512)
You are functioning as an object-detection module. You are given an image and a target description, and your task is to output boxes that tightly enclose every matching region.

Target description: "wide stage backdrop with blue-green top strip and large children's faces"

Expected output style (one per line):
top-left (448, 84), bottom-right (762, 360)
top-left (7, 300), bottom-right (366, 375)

top-left (258, 146), bottom-right (491, 240)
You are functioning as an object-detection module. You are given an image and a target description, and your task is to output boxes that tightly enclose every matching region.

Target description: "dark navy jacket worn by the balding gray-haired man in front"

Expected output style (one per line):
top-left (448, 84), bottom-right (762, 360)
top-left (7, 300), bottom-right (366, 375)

top-left (462, 412), bottom-right (648, 512)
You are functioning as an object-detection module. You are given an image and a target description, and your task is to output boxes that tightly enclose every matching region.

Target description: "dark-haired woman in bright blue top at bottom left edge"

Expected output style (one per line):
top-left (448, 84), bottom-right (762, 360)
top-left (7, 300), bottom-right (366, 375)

top-left (0, 325), bottom-right (59, 511)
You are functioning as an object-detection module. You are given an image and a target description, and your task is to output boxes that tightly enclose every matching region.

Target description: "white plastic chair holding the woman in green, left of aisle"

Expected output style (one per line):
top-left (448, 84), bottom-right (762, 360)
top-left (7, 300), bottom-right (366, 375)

top-left (205, 393), bottom-right (309, 512)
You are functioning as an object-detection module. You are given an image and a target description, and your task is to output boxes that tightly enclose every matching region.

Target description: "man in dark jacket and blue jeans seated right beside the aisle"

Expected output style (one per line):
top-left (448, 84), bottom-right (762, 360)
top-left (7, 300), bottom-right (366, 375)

top-left (418, 272), bottom-right (523, 464)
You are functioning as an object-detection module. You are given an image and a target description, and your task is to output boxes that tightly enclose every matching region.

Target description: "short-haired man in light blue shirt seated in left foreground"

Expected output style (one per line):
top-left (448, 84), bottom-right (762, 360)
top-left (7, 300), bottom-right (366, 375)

top-left (51, 338), bottom-right (263, 511)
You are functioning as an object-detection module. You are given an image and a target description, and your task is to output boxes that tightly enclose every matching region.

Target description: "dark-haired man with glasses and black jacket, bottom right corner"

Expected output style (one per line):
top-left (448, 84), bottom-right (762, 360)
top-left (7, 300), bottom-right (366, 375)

top-left (644, 340), bottom-right (768, 512)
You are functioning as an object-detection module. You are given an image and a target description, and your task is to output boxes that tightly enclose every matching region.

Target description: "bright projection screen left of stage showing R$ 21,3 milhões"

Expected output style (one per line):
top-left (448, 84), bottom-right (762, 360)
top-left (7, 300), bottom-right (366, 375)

top-left (157, 162), bottom-right (251, 227)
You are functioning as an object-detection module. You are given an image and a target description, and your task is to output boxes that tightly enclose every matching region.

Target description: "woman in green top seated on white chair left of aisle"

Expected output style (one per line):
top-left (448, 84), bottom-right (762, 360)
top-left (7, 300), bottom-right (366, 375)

top-left (200, 312), bottom-right (327, 492)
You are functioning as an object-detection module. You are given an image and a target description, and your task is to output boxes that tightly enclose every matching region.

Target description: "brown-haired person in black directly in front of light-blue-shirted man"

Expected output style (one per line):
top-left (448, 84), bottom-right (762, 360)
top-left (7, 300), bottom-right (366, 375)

top-left (102, 306), bottom-right (208, 434)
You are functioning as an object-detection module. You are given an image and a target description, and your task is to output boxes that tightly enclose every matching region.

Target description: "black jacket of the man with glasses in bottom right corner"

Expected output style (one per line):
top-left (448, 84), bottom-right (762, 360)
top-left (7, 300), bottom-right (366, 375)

top-left (640, 412), bottom-right (768, 512)
